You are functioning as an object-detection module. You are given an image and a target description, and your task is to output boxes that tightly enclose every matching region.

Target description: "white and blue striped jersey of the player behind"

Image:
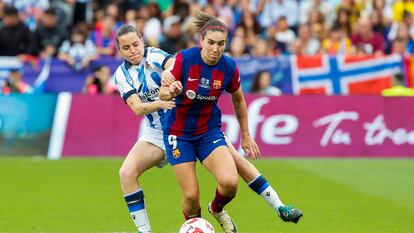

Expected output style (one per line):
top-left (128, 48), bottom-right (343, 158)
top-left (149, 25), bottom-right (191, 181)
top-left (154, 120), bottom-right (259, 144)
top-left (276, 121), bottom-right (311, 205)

top-left (114, 47), bottom-right (173, 129)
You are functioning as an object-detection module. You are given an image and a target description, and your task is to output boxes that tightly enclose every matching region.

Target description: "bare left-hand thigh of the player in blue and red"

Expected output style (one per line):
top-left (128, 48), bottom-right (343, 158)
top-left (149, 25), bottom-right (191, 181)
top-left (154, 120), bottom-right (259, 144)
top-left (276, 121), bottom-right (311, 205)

top-left (172, 162), bottom-right (200, 199)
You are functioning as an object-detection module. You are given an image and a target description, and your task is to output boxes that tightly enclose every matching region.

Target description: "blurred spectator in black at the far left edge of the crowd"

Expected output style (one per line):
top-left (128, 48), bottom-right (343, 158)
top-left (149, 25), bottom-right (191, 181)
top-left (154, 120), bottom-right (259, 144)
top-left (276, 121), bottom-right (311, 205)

top-left (0, 7), bottom-right (37, 56)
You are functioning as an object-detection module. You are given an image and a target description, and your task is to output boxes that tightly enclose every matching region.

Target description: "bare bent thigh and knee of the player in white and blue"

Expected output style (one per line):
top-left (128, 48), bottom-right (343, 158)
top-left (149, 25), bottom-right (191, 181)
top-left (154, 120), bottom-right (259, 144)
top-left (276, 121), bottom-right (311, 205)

top-left (122, 141), bottom-right (164, 173)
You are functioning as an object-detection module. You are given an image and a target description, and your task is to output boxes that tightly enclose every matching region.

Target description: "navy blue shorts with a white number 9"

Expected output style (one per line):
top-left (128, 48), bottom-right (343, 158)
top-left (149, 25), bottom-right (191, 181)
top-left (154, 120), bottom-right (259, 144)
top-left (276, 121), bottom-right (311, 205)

top-left (164, 129), bottom-right (227, 166)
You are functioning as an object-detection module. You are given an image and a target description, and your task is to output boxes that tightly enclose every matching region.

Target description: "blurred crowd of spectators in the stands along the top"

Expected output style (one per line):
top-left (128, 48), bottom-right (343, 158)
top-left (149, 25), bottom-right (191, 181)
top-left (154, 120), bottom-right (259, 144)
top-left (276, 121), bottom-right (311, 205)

top-left (0, 0), bottom-right (414, 95)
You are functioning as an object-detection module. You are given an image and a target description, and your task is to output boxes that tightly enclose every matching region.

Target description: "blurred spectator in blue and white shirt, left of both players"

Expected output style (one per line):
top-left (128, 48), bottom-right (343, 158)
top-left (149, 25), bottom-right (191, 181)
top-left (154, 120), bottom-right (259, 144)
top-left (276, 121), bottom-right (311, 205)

top-left (58, 27), bottom-right (98, 71)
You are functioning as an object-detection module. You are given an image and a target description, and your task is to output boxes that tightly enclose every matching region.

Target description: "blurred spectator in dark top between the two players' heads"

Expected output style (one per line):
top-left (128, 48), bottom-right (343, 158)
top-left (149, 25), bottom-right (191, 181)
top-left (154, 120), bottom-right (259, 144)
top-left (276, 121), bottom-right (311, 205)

top-left (159, 15), bottom-right (187, 54)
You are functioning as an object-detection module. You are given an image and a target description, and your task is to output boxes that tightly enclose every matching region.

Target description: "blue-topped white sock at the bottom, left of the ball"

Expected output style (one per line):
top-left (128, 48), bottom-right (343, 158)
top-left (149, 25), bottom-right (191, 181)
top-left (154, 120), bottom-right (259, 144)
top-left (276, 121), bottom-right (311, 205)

top-left (124, 189), bottom-right (151, 232)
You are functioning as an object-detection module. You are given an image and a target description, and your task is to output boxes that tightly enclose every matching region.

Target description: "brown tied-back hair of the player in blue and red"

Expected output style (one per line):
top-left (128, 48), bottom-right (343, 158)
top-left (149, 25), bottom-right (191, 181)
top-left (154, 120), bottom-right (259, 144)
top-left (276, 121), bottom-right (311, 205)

top-left (194, 11), bottom-right (229, 39)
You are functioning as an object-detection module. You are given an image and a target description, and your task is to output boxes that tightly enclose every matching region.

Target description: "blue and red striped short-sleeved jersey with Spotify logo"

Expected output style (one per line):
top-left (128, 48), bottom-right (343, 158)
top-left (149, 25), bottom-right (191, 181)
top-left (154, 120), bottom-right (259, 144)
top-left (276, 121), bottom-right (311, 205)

top-left (163, 48), bottom-right (240, 138)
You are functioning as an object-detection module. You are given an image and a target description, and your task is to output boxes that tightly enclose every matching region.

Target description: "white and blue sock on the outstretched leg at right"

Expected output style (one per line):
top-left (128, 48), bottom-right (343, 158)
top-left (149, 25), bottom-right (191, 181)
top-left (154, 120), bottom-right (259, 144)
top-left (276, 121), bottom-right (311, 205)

top-left (248, 174), bottom-right (284, 213)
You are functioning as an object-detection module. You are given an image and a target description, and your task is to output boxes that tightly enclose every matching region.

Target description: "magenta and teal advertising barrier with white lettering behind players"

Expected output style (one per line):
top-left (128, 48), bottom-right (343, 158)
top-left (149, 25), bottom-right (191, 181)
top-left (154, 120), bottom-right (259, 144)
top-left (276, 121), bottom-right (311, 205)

top-left (0, 93), bottom-right (414, 158)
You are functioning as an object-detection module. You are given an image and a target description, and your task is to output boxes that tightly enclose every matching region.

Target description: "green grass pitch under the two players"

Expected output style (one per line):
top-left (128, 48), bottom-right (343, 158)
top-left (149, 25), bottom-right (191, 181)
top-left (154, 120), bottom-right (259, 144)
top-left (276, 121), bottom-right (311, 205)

top-left (0, 157), bottom-right (414, 233)
